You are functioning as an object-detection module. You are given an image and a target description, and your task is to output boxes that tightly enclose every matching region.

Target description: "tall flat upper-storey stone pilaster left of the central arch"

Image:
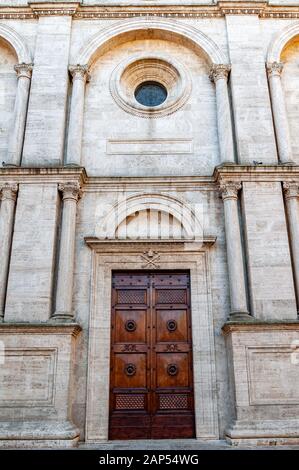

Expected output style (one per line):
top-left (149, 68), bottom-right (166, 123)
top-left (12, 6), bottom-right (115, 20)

top-left (23, 16), bottom-right (72, 166)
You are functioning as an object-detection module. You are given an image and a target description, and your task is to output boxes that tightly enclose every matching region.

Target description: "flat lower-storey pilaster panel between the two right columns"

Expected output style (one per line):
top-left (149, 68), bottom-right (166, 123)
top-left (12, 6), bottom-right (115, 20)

top-left (243, 182), bottom-right (297, 320)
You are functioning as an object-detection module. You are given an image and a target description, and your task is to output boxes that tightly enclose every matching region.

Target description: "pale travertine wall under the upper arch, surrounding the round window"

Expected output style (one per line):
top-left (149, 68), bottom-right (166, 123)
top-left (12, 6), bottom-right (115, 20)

top-left (82, 37), bottom-right (220, 176)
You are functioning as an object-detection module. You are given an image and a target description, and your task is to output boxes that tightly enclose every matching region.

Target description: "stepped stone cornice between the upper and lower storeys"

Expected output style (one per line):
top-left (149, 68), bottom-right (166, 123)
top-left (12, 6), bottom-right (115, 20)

top-left (0, 165), bottom-right (299, 192)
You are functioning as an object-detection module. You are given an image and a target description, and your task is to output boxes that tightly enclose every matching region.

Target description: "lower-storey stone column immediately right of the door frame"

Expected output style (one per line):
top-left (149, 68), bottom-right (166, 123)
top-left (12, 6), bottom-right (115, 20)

top-left (220, 182), bottom-right (251, 320)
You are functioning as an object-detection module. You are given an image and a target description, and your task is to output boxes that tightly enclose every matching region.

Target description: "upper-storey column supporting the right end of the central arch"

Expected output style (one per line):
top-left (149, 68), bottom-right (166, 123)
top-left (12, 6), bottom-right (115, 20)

top-left (210, 64), bottom-right (235, 164)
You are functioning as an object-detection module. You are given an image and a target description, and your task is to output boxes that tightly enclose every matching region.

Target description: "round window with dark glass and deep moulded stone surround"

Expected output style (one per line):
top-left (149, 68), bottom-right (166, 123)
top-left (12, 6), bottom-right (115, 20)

top-left (110, 54), bottom-right (191, 118)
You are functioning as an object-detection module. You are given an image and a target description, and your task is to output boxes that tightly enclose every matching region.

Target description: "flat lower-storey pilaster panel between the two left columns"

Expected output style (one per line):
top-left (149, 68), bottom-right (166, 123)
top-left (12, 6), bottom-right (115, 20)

top-left (5, 184), bottom-right (59, 322)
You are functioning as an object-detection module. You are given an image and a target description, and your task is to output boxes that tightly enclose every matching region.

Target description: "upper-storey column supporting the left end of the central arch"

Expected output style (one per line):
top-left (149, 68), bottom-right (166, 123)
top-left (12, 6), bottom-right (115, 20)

top-left (66, 65), bottom-right (89, 166)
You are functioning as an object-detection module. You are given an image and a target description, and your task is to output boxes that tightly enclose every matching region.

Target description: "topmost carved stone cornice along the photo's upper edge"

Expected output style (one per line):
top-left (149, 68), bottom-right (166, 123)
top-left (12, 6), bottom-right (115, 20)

top-left (0, 1), bottom-right (299, 20)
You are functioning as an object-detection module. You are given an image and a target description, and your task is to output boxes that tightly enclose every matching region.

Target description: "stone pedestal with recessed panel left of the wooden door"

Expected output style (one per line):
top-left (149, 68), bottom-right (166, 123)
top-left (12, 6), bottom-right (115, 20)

top-left (0, 323), bottom-right (81, 448)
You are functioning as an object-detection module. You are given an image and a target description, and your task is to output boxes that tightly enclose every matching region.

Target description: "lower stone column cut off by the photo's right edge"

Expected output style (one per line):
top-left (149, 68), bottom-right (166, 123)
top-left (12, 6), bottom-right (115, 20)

top-left (283, 182), bottom-right (299, 308)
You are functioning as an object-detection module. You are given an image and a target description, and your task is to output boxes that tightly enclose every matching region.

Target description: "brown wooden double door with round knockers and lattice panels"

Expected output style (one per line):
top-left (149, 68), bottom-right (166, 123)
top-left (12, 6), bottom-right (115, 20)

top-left (109, 271), bottom-right (195, 439)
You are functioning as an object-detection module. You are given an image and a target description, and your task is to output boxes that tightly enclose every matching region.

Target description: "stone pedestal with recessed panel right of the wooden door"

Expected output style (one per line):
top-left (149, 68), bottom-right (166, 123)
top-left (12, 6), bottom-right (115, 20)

top-left (223, 321), bottom-right (299, 445)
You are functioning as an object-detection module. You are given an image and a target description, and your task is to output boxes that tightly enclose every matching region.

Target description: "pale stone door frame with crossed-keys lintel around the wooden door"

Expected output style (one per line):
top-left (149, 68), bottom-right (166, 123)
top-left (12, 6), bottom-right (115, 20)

top-left (85, 238), bottom-right (219, 443)
